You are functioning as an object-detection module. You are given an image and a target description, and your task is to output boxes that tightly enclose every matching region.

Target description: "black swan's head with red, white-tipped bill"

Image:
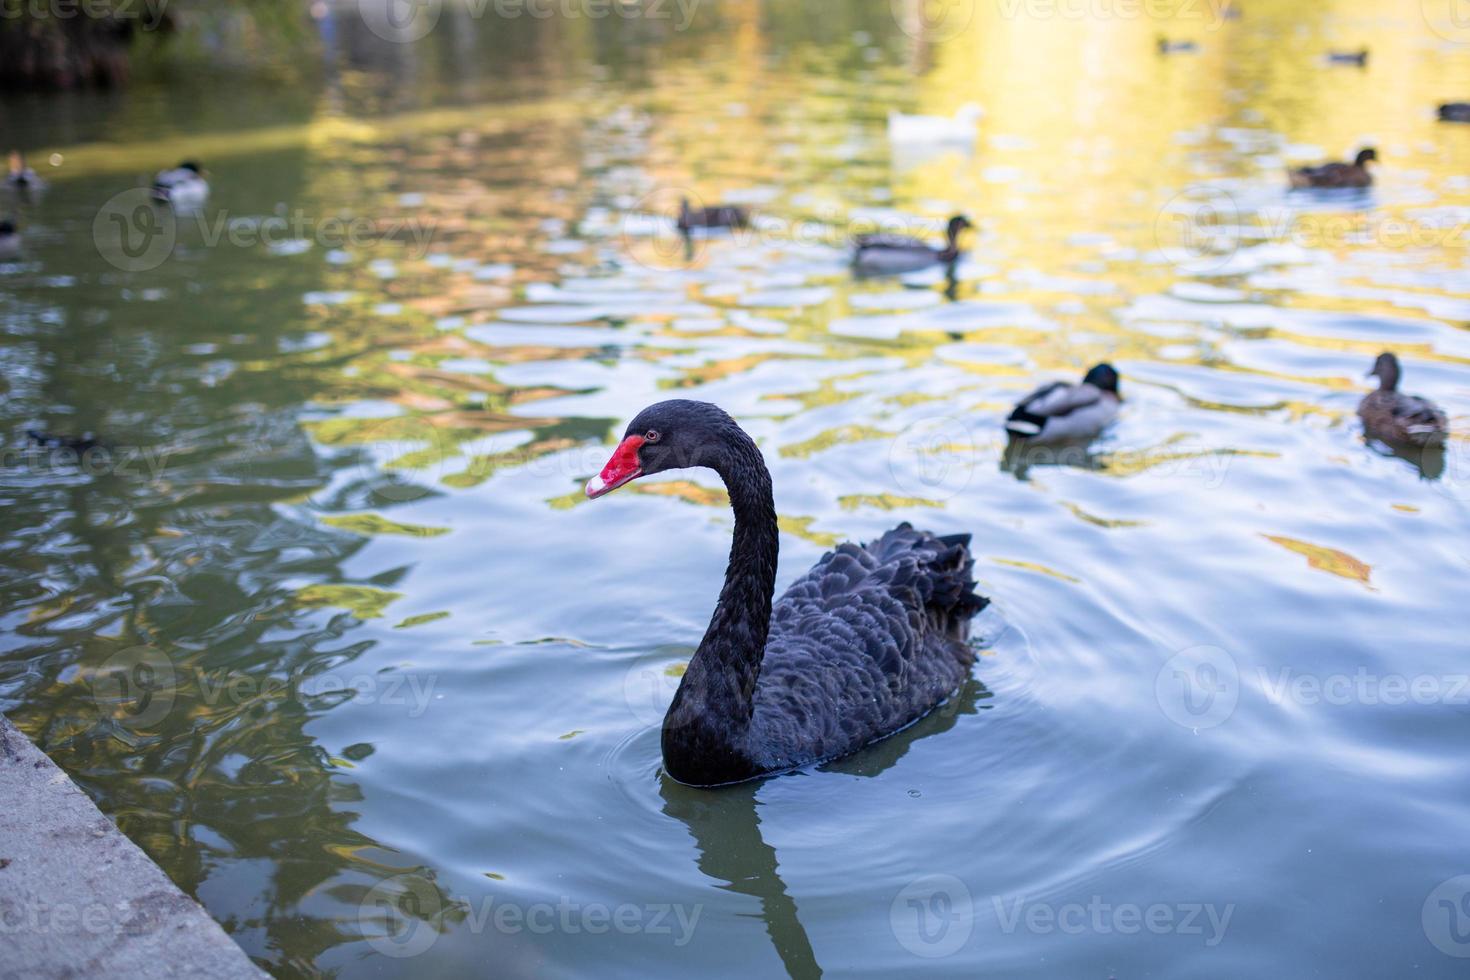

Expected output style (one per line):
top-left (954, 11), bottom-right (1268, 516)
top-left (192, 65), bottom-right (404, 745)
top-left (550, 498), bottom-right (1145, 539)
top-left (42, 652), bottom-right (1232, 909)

top-left (587, 398), bottom-right (742, 500)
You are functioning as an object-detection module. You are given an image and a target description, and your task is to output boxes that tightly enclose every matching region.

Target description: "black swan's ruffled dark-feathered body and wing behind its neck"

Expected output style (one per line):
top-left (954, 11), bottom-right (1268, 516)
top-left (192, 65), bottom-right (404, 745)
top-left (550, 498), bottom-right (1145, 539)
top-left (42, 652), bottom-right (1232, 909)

top-left (750, 525), bottom-right (988, 770)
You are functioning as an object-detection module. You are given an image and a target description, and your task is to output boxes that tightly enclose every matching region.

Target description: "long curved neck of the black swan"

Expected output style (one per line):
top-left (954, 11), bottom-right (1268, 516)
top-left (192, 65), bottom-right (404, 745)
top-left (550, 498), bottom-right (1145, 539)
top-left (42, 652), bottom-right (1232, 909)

top-left (664, 429), bottom-right (779, 751)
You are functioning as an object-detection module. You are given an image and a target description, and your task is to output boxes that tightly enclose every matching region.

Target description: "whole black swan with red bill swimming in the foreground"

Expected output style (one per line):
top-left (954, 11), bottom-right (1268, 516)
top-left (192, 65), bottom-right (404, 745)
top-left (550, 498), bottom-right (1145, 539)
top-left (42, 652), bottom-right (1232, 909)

top-left (587, 400), bottom-right (989, 786)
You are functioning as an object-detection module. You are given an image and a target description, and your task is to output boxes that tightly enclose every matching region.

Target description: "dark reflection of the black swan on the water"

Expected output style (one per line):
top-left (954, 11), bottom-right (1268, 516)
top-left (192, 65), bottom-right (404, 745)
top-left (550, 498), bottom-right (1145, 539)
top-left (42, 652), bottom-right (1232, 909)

top-left (659, 677), bottom-right (992, 980)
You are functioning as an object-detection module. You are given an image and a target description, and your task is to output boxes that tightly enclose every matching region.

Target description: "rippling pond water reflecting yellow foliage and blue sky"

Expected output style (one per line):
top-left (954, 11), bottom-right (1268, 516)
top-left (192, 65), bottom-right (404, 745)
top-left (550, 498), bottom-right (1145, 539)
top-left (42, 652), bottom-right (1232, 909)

top-left (0, 0), bottom-right (1470, 977)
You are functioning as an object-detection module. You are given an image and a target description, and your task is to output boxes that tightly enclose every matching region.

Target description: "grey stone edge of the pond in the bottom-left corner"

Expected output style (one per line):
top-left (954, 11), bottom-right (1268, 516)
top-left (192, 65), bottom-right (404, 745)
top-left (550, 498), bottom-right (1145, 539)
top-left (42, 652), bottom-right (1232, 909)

top-left (0, 714), bottom-right (266, 980)
